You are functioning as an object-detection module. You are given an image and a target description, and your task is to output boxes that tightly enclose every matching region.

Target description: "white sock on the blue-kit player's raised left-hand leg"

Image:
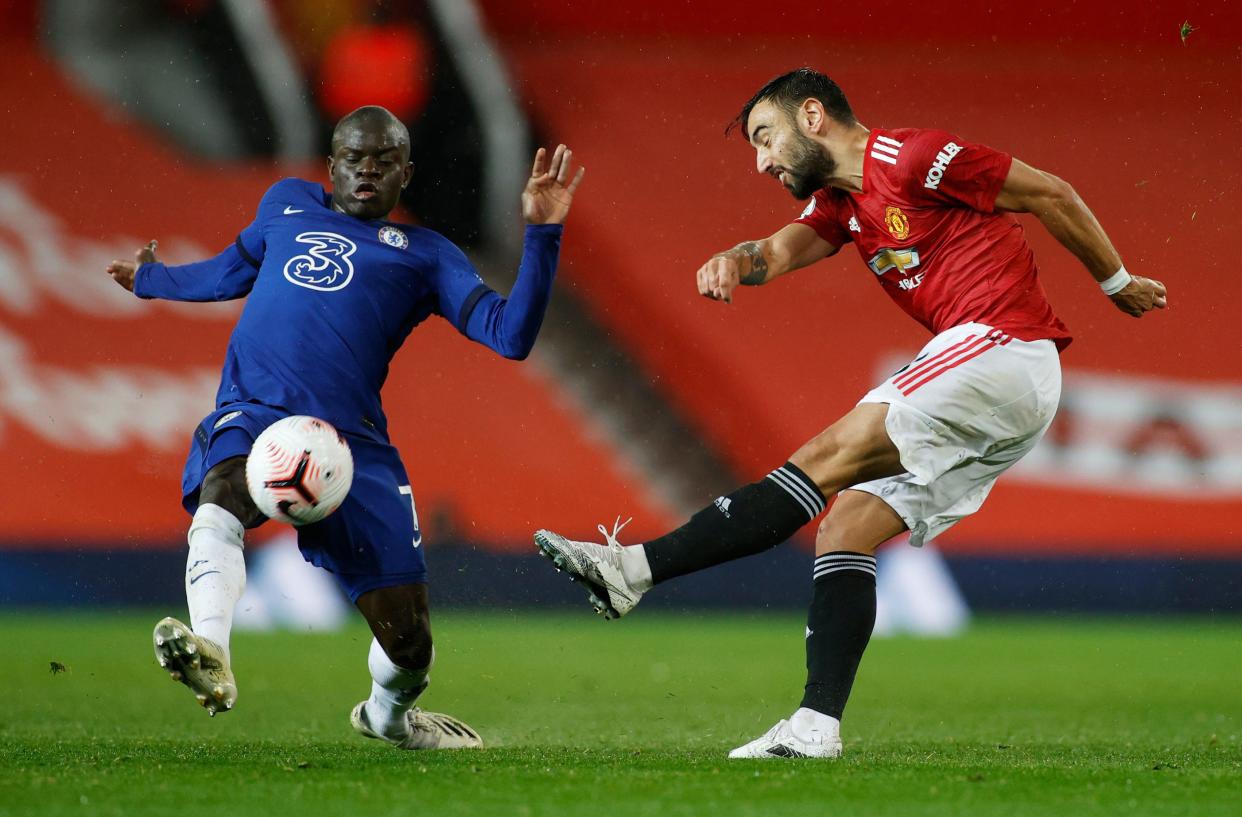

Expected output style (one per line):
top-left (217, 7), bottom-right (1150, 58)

top-left (185, 503), bottom-right (246, 657)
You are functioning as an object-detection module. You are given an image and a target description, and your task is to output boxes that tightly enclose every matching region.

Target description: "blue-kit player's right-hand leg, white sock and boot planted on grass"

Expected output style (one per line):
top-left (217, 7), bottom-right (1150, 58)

top-left (349, 585), bottom-right (483, 749)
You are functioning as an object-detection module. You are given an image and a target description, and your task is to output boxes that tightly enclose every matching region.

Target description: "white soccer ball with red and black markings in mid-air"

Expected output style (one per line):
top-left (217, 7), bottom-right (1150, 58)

top-left (246, 415), bottom-right (354, 525)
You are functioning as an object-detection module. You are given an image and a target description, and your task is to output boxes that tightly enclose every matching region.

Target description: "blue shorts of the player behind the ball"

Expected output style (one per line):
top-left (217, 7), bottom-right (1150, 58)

top-left (181, 402), bottom-right (427, 601)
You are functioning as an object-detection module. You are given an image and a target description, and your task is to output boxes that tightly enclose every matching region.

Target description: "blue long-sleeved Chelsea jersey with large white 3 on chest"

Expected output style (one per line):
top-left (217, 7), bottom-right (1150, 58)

top-left (134, 179), bottom-right (560, 441)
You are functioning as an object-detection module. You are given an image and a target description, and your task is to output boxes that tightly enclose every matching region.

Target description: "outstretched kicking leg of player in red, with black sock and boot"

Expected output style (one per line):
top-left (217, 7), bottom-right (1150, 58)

top-left (535, 404), bottom-right (904, 618)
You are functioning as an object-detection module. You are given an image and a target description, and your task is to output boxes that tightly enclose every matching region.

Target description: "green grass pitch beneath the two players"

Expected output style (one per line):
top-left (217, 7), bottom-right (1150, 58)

top-left (0, 610), bottom-right (1242, 817)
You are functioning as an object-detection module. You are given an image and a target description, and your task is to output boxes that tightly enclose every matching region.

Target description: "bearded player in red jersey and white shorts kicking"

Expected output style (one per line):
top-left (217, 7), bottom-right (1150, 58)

top-left (535, 68), bottom-right (1166, 757)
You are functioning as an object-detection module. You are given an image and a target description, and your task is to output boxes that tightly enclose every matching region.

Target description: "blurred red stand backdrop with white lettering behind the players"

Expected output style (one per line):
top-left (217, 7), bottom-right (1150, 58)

top-left (0, 0), bottom-right (1242, 555)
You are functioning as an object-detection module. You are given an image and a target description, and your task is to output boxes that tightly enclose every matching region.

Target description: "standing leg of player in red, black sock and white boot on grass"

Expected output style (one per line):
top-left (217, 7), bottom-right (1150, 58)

top-left (729, 490), bottom-right (905, 759)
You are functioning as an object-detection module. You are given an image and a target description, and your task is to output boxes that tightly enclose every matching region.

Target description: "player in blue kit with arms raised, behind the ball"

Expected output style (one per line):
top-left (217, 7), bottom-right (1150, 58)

top-left (108, 107), bottom-right (584, 749)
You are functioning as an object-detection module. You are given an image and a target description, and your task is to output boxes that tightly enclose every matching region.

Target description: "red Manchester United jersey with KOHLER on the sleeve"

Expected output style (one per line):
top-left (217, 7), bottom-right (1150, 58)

top-left (796, 128), bottom-right (1069, 349)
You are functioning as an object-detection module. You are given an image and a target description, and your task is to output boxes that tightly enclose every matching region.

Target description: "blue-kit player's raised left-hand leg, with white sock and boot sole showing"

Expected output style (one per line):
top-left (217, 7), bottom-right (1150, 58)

top-left (152, 457), bottom-right (262, 715)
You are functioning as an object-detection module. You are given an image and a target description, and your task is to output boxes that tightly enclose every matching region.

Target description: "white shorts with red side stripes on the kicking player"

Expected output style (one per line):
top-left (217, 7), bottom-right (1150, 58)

top-left (852, 323), bottom-right (1061, 546)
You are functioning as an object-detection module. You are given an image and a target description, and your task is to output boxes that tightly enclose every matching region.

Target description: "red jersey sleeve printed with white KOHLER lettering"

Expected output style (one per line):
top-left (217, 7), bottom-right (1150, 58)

top-left (905, 130), bottom-right (1013, 212)
